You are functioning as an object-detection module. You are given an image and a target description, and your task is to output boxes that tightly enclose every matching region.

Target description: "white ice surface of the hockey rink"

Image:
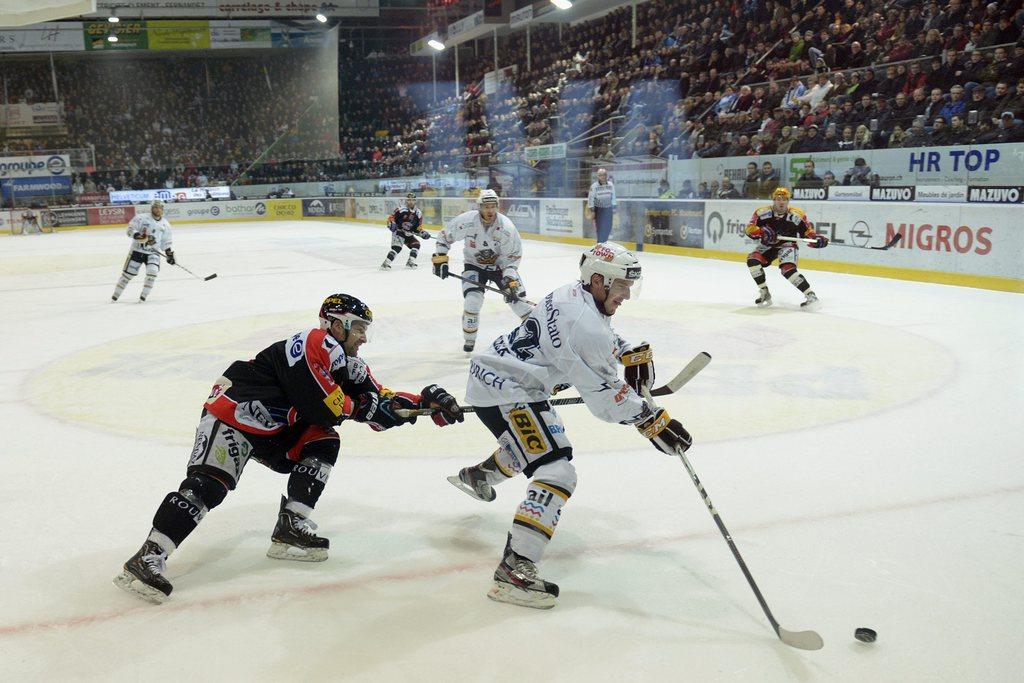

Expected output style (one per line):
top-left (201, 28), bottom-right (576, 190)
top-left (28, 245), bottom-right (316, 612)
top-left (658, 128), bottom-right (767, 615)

top-left (0, 221), bottom-right (1024, 682)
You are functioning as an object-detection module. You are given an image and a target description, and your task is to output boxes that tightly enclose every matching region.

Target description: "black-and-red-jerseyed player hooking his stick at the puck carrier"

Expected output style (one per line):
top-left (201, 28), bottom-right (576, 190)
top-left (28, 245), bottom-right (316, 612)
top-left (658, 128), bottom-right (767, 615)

top-left (114, 294), bottom-right (464, 603)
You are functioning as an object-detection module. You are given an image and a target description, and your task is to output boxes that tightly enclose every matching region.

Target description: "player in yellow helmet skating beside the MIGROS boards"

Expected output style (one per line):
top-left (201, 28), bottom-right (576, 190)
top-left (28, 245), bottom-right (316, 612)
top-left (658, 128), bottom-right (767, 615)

top-left (746, 187), bottom-right (828, 307)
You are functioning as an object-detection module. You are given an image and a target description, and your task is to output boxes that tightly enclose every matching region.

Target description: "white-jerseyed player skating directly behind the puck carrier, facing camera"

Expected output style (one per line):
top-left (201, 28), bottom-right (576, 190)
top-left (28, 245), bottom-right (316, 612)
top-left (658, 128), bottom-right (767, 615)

top-left (433, 189), bottom-right (532, 352)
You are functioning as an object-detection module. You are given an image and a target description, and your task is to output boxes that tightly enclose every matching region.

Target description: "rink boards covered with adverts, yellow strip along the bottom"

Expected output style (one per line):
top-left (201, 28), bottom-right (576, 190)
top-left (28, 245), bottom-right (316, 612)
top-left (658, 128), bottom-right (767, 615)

top-left (9, 197), bottom-right (1024, 293)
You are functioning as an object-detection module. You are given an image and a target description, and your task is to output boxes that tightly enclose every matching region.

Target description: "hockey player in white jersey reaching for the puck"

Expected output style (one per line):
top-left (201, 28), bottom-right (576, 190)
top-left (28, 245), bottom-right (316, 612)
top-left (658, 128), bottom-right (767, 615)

top-left (449, 243), bottom-right (691, 609)
